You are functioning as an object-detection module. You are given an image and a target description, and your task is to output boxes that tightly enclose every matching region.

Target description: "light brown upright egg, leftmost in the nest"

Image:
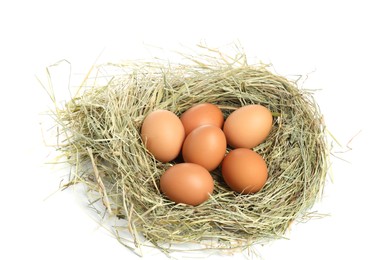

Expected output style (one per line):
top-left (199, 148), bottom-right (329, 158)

top-left (141, 109), bottom-right (185, 162)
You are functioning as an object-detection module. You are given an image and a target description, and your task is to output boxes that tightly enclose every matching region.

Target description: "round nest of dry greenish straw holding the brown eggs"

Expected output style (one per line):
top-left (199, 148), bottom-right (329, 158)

top-left (56, 46), bottom-right (328, 254)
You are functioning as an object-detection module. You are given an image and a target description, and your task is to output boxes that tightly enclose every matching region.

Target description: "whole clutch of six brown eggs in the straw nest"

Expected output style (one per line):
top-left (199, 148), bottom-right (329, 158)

top-left (141, 103), bottom-right (273, 206)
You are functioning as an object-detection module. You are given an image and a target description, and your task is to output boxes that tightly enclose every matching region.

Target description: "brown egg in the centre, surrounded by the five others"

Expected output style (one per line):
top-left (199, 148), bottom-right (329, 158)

top-left (182, 125), bottom-right (227, 171)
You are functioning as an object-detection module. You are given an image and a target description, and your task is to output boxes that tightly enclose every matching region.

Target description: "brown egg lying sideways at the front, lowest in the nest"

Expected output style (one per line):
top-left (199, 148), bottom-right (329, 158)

top-left (160, 163), bottom-right (213, 206)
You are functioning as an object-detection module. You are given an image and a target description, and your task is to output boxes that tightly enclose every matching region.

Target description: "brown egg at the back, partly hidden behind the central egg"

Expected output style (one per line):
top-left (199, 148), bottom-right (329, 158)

top-left (181, 103), bottom-right (224, 136)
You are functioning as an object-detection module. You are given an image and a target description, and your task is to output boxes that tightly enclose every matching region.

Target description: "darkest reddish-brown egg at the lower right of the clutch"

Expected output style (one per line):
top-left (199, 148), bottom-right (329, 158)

top-left (221, 148), bottom-right (268, 194)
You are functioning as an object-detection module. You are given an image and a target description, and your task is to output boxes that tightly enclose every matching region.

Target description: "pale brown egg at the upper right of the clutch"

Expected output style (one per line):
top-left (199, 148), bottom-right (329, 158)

top-left (223, 105), bottom-right (273, 148)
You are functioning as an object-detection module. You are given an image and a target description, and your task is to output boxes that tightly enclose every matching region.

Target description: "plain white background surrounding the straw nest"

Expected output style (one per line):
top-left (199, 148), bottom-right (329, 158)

top-left (0, 0), bottom-right (391, 260)
